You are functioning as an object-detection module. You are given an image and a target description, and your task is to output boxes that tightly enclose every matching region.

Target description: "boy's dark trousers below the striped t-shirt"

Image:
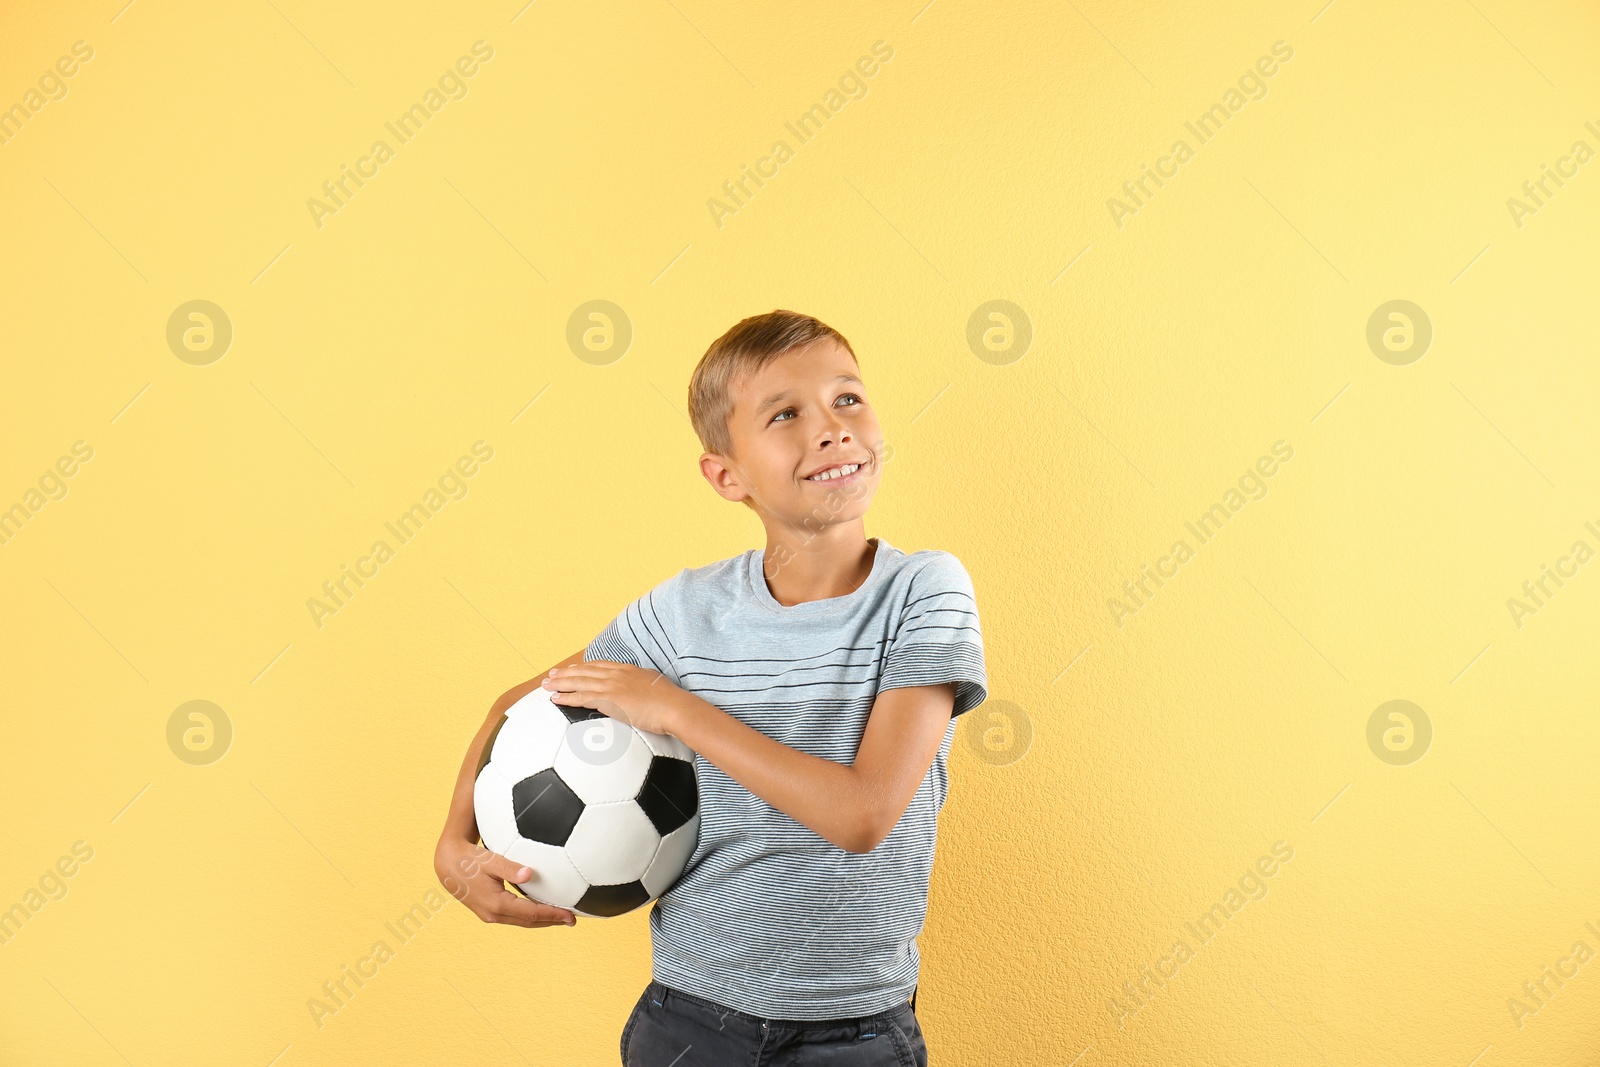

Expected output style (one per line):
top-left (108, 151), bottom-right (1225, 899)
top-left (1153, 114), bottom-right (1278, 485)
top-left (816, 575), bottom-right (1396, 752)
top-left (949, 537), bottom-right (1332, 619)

top-left (622, 981), bottom-right (928, 1067)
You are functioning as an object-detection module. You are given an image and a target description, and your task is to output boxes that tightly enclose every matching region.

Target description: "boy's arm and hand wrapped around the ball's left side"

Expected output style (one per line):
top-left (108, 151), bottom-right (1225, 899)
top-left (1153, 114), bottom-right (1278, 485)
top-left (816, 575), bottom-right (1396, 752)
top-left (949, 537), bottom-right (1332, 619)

top-left (434, 649), bottom-right (584, 926)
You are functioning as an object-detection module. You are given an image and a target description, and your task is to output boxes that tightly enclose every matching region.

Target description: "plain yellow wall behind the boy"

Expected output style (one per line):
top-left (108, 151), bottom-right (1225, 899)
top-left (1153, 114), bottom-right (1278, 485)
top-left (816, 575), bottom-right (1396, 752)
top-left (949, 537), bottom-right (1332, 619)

top-left (0, 0), bottom-right (1600, 1067)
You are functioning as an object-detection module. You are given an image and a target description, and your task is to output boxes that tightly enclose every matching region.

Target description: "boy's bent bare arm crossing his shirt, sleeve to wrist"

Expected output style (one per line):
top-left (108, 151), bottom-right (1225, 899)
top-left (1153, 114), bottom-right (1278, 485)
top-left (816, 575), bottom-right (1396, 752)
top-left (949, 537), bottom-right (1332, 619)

top-left (670, 681), bottom-right (955, 853)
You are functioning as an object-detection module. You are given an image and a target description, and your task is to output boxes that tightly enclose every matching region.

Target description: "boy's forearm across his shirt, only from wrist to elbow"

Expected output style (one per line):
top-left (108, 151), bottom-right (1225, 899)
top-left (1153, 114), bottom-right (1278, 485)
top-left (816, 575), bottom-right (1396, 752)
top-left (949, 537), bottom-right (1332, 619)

top-left (659, 689), bottom-right (866, 851)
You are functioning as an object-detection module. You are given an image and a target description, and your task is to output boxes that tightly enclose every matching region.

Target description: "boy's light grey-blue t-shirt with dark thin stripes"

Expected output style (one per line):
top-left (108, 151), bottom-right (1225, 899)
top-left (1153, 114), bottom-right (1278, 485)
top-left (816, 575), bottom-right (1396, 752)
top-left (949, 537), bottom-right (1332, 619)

top-left (584, 537), bottom-right (989, 1019)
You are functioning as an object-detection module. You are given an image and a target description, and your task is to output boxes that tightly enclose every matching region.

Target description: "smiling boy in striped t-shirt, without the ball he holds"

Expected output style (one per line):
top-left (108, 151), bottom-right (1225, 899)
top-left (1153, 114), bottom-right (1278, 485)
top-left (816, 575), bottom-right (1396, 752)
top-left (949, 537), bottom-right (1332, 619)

top-left (434, 310), bottom-right (987, 1067)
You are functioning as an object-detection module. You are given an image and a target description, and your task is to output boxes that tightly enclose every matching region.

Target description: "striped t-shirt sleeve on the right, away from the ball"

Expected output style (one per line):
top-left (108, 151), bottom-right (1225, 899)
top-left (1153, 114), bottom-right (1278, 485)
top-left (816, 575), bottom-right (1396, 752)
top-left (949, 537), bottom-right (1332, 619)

top-left (878, 552), bottom-right (989, 718)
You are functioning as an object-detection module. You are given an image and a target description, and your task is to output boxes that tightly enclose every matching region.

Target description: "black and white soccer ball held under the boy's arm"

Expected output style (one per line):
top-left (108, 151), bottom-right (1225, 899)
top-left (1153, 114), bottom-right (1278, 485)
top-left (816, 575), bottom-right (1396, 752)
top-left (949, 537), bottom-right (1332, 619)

top-left (474, 689), bottom-right (699, 917)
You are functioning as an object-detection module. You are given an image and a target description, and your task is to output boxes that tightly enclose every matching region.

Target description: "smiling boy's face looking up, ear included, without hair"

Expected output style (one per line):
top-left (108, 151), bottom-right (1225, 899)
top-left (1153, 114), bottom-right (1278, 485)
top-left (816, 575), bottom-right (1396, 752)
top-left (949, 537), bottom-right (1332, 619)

top-left (701, 338), bottom-right (883, 533)
